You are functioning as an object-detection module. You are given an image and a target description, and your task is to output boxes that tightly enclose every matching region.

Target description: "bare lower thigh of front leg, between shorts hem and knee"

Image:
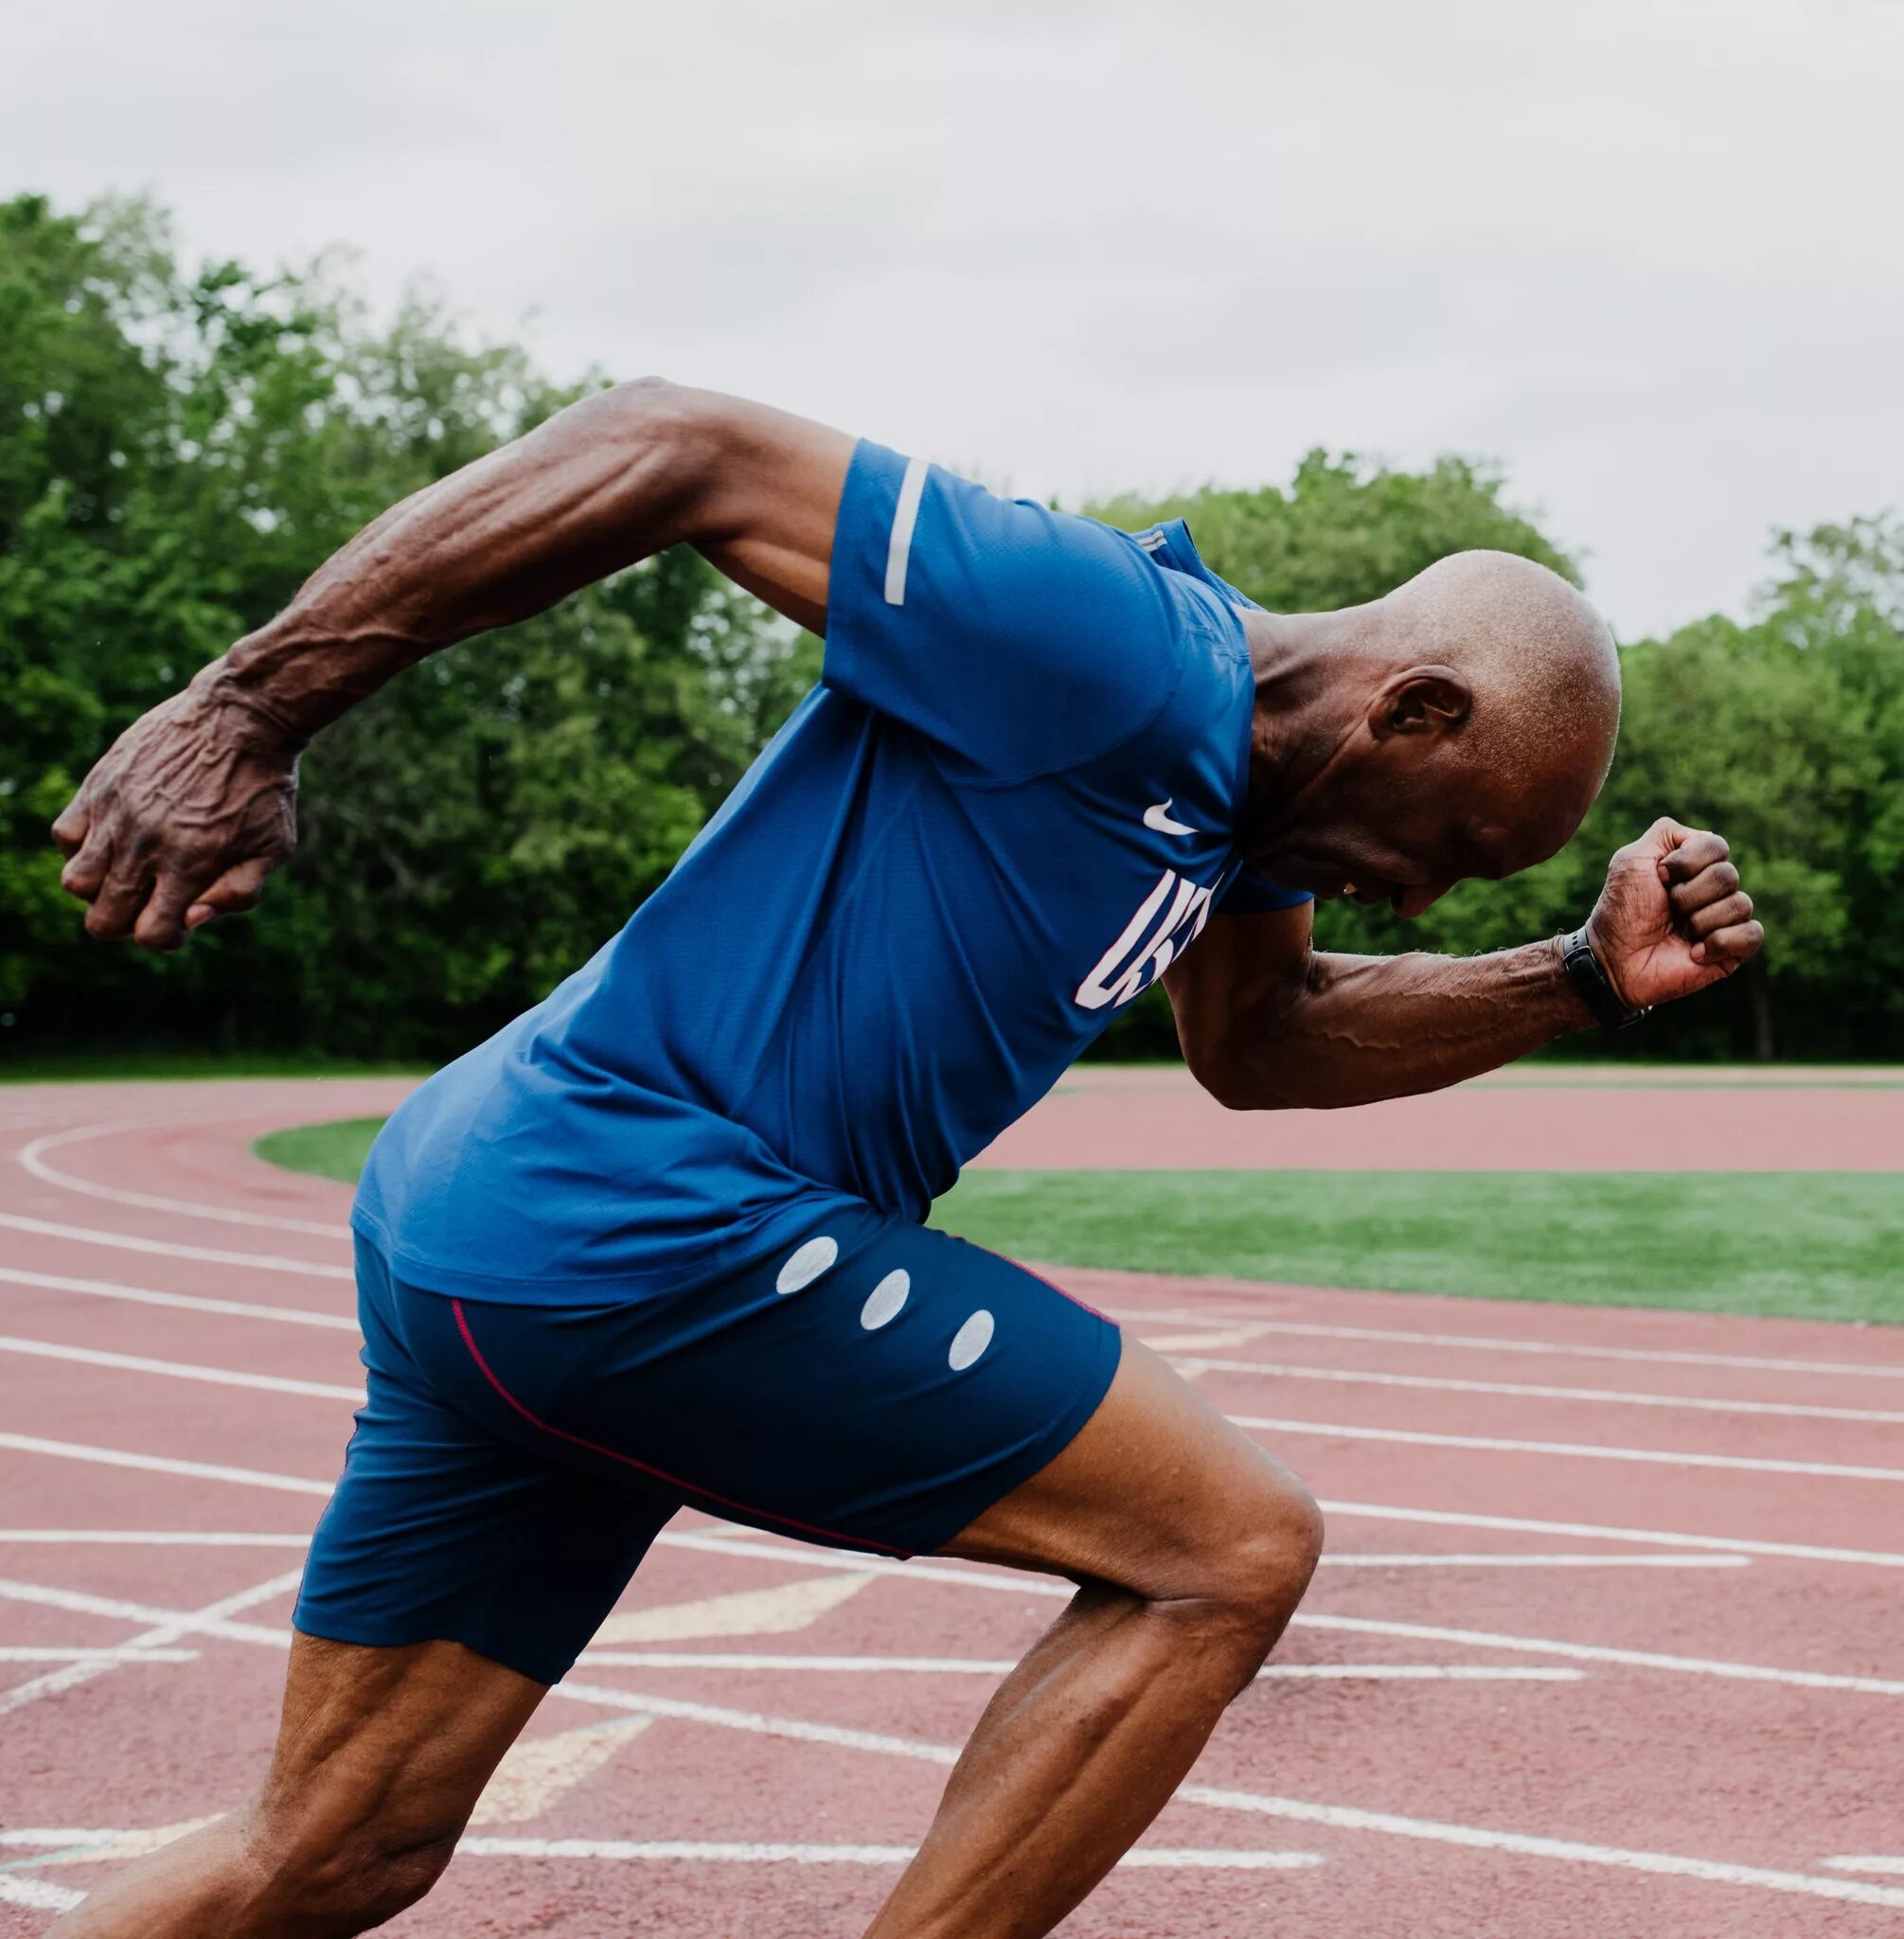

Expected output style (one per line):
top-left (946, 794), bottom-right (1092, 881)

top-left (944, 1340), bottom-right (1321, 1598)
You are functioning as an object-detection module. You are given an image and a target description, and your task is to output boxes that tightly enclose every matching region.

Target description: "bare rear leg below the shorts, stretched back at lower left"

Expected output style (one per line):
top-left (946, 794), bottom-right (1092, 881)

top-left (52, 1634), bottom-right (543, 1939)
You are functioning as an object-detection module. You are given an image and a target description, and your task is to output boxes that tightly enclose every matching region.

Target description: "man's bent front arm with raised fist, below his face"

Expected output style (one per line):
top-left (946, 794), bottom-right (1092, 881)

top-left (1166, 820), bottom-right (1765, 1112)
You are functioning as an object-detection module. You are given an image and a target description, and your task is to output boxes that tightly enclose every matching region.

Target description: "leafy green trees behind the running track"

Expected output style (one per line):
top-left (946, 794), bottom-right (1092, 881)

top-left (0, 196), bottom-right (1904, 1062)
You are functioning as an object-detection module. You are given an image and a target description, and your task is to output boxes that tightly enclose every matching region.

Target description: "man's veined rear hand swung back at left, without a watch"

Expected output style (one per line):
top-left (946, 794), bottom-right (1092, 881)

top-left (52, 663), bottom-right (296, 951)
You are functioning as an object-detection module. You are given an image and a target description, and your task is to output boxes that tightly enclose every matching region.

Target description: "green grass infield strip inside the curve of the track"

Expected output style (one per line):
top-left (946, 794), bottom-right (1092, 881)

top-left (256, 1119), bottom-right (1904, 1325)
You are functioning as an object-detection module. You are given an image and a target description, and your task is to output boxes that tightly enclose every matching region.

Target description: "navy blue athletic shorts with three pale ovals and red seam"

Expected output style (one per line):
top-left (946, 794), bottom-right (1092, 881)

top-left (294, 1206), bottom-right (1121, 1683)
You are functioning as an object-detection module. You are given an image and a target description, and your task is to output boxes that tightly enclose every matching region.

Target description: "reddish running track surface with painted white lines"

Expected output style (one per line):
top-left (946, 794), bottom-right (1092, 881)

top-left (0, 1076), bottom-right (1904, 1939)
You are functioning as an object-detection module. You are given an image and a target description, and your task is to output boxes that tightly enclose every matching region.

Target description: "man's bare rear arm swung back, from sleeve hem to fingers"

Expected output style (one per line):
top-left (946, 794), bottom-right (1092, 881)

top-left (52, 378), bottom-right (853, 951)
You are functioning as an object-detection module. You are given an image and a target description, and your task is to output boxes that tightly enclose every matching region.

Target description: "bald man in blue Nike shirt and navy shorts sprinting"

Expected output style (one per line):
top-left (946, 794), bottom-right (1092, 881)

top-left (54, 382), bottom-right (1760, 1939)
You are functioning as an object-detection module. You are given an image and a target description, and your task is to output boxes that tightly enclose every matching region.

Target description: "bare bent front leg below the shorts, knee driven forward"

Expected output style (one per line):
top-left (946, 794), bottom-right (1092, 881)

top-left (866, 1342), bottom-right (1323, 1939)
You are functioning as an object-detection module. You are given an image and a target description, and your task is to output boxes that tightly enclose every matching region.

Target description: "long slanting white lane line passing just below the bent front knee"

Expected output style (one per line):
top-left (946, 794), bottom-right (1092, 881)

top-left (0, 1435), bottom-right (1904, 1697)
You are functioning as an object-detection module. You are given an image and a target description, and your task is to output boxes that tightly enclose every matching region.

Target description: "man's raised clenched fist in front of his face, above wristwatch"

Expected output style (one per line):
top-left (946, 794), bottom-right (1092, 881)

top-left (1586, 814), bottom-right (1765, 1010)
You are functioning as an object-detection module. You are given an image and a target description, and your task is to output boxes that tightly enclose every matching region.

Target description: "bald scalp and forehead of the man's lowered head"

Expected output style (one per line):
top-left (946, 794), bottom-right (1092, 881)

top-left (1367, 553), bottom-right (1619, 799)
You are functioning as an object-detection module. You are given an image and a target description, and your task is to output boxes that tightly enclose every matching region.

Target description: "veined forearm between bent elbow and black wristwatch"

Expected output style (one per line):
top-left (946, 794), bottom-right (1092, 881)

top-left (1221, 940), bottom-right (1593, 1112)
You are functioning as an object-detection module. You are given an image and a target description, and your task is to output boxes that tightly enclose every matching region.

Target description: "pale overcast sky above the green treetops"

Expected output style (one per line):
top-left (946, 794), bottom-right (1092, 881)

top-left (0, 0), bottom-right (1904, 636)
